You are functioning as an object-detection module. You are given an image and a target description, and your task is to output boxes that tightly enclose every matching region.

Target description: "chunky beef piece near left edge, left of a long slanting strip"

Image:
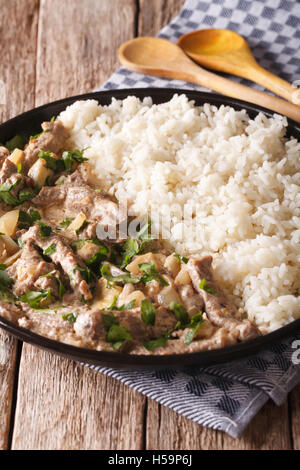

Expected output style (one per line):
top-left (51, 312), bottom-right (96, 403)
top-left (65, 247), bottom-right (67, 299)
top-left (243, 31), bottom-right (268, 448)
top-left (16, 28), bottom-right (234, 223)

top-left (7, 240), bottom-right (58, 295)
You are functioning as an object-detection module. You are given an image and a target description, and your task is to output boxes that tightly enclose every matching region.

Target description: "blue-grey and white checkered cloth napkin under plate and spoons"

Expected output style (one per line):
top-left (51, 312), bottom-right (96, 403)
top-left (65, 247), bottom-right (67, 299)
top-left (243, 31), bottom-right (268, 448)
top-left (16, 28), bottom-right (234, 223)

top-left (89, 0), bottom-right (300, 437)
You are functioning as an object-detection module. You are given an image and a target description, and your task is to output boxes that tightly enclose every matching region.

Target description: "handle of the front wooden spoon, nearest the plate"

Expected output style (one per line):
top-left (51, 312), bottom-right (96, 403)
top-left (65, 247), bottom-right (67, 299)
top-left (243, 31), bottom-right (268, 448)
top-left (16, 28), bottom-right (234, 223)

top-left (173, 62), bottom-right (300, 122)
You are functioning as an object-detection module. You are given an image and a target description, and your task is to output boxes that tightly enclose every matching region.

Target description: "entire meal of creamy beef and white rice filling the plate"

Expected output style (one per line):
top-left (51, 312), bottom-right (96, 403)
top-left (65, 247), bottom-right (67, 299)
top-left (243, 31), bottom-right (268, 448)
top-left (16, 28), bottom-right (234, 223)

top-left (0, 95), bottom-right (300, 355)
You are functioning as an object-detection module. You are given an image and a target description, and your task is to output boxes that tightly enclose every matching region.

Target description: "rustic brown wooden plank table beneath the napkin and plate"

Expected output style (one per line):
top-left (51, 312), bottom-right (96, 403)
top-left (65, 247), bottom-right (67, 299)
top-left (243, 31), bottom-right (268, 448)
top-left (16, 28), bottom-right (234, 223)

top-left (0, 0), bottom-right (300, 450)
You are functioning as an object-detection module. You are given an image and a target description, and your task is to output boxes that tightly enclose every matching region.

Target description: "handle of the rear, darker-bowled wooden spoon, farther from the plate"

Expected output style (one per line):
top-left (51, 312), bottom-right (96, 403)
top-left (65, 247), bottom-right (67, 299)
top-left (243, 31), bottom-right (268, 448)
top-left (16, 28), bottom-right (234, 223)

top-left (245, 64), bottom-right (300, 105)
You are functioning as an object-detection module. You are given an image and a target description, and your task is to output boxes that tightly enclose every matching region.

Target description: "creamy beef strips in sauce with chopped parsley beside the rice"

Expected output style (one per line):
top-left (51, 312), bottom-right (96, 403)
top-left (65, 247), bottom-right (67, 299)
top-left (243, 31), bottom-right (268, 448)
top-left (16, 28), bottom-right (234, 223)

top-left (0, 117), bottom-right (259, 354)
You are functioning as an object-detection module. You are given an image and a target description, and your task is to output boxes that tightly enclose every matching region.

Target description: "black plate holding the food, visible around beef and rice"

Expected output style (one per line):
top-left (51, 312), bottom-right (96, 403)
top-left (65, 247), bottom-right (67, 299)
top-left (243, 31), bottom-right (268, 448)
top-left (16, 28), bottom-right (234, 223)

top-left (0, 88), bottom-right (300, 368)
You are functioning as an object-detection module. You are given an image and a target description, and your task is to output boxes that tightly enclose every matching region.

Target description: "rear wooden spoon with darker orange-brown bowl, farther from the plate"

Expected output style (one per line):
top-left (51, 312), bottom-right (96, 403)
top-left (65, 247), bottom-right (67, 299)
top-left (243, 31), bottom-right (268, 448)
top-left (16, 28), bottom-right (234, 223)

top-left (178, 29), bottom-right (297, 104)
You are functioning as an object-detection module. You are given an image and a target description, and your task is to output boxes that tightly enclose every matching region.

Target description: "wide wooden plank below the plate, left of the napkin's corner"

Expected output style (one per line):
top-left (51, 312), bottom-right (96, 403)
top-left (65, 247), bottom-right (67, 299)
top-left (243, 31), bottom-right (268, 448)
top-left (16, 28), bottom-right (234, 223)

top-left (12, 345), bottom-right (145, 450)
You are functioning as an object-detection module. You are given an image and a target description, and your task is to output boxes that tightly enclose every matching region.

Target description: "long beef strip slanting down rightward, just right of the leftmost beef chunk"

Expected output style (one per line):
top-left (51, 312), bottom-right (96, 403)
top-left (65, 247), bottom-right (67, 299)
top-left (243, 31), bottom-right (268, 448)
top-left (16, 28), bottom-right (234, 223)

top-left (22, 225), bottom-right (92, 300)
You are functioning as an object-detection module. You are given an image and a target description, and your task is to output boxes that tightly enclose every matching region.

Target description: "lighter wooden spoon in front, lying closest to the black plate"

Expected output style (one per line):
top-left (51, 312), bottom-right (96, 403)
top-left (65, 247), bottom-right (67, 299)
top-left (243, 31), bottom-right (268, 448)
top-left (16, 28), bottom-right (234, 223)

top-left (119, 37), bottom-right (300, 122)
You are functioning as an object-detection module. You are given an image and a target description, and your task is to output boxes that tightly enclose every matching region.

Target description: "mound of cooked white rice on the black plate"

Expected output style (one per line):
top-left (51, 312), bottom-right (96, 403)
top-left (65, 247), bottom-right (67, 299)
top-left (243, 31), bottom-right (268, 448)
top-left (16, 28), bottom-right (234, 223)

top-left (59, 95), bottom-right (300, 331)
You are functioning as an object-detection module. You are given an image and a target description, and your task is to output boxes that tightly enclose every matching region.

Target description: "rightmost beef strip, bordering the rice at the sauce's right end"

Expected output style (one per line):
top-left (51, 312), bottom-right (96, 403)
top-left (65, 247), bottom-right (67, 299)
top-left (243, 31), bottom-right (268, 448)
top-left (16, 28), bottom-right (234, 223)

top-left (188, 256), bottom-right (260, 341)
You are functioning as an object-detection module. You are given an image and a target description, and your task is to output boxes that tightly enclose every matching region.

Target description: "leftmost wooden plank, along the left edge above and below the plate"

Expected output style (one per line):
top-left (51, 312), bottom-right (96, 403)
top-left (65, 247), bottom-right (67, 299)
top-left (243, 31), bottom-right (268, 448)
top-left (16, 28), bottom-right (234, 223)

top-left (0, 0), bottom-right (39, 450)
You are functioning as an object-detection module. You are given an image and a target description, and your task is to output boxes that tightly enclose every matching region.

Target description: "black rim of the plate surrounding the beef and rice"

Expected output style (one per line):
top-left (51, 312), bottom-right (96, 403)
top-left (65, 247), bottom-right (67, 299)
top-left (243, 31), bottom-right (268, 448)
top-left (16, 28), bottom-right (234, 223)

top-left (0, 87), bottom-right (300, 369)
